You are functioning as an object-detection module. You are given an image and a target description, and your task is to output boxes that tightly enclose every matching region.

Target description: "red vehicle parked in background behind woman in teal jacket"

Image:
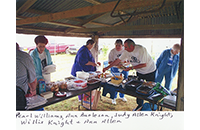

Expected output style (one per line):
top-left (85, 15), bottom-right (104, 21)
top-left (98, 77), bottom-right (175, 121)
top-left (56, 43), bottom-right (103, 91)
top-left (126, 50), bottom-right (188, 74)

top-left (28, 43), bottom-right (74, 54)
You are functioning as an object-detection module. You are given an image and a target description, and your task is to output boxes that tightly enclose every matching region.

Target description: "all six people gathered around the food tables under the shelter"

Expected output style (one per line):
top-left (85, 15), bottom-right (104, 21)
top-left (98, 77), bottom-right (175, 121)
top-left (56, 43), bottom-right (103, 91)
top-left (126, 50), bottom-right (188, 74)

top-left (16, 36), bottom-right (180, 110)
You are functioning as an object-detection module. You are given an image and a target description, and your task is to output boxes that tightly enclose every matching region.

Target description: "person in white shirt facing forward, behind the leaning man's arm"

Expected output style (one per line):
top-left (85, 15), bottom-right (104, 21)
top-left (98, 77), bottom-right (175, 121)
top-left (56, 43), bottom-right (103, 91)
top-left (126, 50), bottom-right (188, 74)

top-left (108, 39), bottom-right (128, 104)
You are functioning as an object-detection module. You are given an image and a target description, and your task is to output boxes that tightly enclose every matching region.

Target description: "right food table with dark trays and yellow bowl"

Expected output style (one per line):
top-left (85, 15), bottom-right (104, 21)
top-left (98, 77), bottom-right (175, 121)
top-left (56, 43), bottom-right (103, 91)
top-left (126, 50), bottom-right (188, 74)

top-left (102, 72), bottom-right (176, 111)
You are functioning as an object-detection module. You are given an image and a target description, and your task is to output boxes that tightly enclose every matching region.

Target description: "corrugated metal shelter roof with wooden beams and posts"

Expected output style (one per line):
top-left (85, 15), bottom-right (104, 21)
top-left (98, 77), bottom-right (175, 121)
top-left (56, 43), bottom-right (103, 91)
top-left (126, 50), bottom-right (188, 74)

top-left (16, 0), bottom-right (184, 110)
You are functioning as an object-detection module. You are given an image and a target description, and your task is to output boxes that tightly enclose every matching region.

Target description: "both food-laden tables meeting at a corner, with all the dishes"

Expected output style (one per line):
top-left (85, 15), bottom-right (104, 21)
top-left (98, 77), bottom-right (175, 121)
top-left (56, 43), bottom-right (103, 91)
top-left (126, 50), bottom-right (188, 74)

top-left (26, 71), bottom-right (175, 110)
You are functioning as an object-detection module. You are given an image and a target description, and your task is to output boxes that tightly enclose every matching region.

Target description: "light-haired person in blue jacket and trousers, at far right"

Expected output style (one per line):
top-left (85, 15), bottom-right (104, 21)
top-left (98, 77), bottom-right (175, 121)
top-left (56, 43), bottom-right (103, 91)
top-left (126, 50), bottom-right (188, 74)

top-left (155, 44), bottom-right (180, 91)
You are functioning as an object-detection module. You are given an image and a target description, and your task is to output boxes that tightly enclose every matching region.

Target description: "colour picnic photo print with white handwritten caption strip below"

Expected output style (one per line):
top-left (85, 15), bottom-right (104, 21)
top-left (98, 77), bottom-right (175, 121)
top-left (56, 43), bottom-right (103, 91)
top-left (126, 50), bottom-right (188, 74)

top-left (12, 0), bottom-right (186, 130)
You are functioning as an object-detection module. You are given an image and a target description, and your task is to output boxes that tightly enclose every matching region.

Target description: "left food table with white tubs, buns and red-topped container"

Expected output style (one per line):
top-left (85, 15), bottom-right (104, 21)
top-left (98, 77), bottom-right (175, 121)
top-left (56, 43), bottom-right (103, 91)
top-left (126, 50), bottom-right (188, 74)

top-left (26, 72), bottom-right (110, 110)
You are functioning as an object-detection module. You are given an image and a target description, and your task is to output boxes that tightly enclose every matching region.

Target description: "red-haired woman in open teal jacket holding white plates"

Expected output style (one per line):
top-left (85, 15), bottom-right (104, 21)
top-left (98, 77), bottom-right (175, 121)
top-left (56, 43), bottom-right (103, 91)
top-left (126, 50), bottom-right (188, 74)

top-left (30, 36), bottom-right (53, 82)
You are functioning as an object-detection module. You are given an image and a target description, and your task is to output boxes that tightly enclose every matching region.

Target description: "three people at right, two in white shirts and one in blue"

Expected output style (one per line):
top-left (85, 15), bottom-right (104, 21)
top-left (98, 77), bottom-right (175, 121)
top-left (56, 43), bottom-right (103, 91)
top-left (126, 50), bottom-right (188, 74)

top-left (103, 39), bottom-right (180, 110)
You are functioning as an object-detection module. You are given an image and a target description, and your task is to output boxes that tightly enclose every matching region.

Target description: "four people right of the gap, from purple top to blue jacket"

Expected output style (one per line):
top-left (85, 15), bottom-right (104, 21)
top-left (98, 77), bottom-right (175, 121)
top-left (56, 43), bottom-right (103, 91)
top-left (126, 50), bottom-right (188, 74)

top-left (71, 39), bottom-right (180, 109)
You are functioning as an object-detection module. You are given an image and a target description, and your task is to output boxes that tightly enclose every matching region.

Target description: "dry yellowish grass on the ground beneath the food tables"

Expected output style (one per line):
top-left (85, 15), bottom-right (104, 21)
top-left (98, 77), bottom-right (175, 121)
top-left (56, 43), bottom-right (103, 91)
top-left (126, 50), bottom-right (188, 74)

top-left (45, 94), bottom-right (137, 111)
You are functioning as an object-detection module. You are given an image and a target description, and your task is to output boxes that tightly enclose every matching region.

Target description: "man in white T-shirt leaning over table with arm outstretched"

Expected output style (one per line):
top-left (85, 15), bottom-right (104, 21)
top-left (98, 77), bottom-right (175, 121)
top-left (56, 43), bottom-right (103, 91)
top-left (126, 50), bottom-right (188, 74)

top-left (103, 39), bottom-right (156, 109)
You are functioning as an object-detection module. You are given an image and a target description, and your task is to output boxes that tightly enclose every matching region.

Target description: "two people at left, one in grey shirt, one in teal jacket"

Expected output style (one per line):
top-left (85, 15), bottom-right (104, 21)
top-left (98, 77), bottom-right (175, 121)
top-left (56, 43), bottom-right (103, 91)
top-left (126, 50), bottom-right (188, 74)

top-left (16, 36), bottom-right (53, 110)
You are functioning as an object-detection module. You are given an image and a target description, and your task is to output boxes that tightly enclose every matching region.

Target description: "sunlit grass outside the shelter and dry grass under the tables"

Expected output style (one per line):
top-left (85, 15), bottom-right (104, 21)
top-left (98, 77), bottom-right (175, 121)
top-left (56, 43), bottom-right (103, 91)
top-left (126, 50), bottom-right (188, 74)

top-left (44, 54), bottom-right (177, 111)
